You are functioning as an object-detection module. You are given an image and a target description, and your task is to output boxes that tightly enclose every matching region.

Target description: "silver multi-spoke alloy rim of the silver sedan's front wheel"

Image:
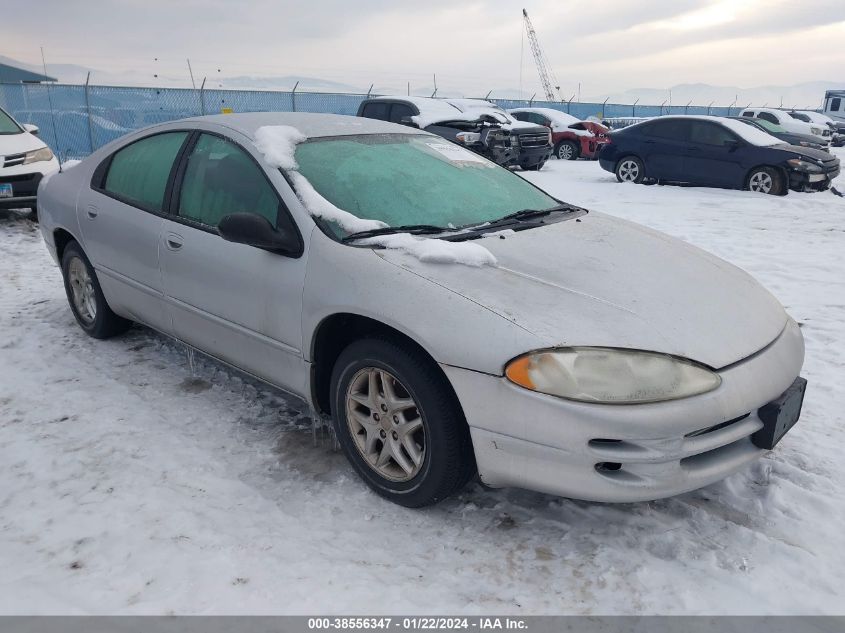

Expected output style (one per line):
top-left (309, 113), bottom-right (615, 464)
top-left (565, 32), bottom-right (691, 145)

top-left (346, 367), bottom-right (426, 482)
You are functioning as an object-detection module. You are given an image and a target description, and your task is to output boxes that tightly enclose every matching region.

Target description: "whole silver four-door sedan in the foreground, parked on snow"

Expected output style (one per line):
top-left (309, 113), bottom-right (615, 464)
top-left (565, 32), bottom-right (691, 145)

top-left (39, 113), bottom-right (805, 507)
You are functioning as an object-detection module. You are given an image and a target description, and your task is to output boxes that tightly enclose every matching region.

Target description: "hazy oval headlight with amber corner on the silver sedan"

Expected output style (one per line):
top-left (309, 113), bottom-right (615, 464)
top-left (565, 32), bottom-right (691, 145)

top-left (505, 347), bottom-right (722, 404)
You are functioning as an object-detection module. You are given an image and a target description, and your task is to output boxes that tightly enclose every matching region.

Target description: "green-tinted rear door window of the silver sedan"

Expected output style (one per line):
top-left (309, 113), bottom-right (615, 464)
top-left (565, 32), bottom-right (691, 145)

top-left (105, 132), bottom-right (188, 211)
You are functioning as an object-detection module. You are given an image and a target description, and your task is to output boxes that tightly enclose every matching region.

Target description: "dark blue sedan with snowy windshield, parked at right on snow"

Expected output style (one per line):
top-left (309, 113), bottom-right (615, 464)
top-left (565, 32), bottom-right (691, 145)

top-left (599, 116), bottom-right (839, 195)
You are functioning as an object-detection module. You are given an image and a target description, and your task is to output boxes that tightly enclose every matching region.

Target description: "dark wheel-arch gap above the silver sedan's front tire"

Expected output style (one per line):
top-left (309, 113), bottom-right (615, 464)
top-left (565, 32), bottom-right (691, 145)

top-left (309, 312), bottom-right (463, 414)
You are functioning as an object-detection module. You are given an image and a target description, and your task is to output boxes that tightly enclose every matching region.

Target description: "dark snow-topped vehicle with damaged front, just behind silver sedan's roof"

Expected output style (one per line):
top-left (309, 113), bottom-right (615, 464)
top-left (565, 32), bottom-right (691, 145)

top-left (358, 96), bottom-right (519, 165)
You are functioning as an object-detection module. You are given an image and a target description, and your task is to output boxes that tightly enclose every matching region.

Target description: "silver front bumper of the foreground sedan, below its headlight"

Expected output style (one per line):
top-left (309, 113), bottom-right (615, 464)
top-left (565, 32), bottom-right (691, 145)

top-left (443, 319), bottom-right (804, 502)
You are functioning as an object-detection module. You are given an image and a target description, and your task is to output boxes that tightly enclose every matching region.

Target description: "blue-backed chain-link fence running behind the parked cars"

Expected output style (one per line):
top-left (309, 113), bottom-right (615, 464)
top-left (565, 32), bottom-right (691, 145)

top-left (0, 83), bottom-right (739, 161)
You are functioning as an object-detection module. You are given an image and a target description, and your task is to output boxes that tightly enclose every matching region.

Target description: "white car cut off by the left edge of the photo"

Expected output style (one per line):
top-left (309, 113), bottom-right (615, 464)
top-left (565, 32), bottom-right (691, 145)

top-left (0, 108), bottom-right (59, 216)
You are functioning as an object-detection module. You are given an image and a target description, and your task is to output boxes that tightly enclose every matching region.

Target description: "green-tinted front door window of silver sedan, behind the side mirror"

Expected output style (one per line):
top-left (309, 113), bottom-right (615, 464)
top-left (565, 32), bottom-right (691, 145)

top-left (179, 134), bottom-right (279, 226)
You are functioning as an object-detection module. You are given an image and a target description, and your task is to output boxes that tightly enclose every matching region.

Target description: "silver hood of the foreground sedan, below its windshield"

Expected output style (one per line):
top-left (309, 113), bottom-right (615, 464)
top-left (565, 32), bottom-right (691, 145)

top-left (377, 213), bottom-right (787, 368)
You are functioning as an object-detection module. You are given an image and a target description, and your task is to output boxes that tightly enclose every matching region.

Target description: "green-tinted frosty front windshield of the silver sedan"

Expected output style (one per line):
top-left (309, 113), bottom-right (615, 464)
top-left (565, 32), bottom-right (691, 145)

top-left (296, 134), bottom-right (557, 235)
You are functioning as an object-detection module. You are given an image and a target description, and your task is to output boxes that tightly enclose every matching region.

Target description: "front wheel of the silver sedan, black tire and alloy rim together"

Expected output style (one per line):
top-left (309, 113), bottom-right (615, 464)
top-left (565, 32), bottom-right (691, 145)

top-left (331, 338), bottom-right (475, 508)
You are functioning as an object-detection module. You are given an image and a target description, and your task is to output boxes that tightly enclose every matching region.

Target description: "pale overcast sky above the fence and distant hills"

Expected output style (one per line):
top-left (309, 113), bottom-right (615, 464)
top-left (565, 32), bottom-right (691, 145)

top-left (0, 0), bottom-right (845, 98)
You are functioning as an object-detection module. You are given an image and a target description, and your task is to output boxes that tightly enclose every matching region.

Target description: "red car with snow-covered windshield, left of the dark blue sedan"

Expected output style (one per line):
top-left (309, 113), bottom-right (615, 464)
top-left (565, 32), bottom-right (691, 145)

top-left (508, 108), bottom-right (610, 160)
